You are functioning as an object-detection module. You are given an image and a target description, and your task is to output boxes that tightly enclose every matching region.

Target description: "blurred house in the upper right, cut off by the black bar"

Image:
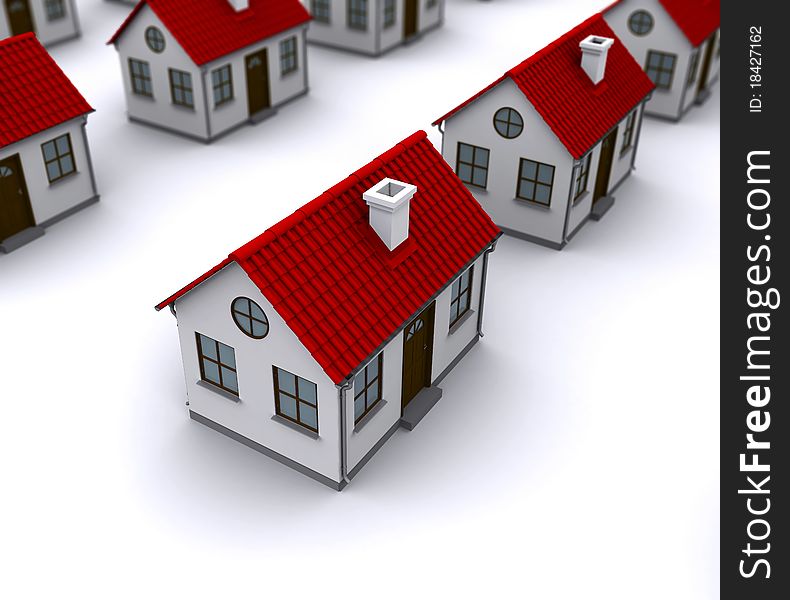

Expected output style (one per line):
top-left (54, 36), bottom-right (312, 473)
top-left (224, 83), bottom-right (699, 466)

top-left (604, 0), bottom-right (720, 121)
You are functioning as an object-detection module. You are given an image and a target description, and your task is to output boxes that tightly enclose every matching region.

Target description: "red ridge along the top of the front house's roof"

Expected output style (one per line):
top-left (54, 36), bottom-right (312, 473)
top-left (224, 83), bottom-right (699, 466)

top-left (229, 130), bottom-right (428, 261)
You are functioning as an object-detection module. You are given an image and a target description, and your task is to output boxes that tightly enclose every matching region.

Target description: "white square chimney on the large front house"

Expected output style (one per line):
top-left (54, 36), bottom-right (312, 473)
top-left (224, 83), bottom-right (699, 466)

top-left (362, 177), bottom-right (417, 250)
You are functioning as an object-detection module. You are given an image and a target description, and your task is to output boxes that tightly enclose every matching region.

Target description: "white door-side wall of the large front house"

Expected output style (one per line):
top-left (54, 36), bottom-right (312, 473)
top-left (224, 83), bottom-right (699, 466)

top-left (345, 256), bottom-right (483, 471)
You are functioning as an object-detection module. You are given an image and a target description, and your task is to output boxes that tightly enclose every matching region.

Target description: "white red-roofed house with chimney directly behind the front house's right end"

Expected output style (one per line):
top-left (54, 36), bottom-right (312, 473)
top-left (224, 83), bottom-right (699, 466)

top-left (434, 14), bottom-right (653, 249)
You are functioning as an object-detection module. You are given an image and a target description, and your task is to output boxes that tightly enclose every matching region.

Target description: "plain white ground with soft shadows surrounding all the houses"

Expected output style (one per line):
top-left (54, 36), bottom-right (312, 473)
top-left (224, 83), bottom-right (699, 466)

top-left (0, 0), bottom-right (719, 600)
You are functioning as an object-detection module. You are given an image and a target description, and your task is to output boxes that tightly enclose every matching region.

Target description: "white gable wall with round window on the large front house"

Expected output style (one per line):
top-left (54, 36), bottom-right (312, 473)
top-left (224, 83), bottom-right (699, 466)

top-left (175, 263), bottom-right (340, 481)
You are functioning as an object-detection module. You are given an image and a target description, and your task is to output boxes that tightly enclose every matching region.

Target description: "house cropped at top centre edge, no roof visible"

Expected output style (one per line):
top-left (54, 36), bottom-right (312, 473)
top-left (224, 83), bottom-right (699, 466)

top-left (307, 0), bottom-right (445, 56)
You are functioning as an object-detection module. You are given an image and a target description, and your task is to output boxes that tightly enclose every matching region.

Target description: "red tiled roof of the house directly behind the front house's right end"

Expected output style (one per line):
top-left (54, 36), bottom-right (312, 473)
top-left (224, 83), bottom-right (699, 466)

top-left (434, 14), bottom-right (655, 159)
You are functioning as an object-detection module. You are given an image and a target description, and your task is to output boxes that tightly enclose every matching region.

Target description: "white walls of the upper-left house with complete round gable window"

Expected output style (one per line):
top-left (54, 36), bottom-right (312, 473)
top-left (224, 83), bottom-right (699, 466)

top-left (117, 6), bottom-right (307, 139)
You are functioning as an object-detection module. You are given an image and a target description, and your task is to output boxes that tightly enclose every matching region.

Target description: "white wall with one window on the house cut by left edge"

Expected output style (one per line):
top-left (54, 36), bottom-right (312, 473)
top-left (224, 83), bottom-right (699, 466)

top-left (0, 117), bottom-right (94, 224)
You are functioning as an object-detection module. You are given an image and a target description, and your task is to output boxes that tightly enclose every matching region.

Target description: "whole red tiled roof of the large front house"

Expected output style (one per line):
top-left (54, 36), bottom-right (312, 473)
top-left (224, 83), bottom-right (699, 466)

top-left (156, 131), bottom-right (500, 383)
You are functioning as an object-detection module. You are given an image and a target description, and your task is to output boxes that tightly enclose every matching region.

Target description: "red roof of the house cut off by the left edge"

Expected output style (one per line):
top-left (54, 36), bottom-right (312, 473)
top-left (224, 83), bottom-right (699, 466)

top-left (0, 33), bottom-right (93, 147)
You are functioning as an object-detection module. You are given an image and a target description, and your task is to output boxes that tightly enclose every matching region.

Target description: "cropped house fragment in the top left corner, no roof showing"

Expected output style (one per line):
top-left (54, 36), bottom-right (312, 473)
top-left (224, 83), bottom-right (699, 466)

top-left (0, 0), bottom-right (80, 46)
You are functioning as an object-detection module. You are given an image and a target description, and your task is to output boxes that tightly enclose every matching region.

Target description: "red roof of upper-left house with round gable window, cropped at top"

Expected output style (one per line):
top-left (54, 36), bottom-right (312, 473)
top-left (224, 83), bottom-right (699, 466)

top-left (108, 0), bottom-right (310, 65)
